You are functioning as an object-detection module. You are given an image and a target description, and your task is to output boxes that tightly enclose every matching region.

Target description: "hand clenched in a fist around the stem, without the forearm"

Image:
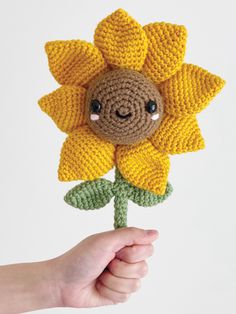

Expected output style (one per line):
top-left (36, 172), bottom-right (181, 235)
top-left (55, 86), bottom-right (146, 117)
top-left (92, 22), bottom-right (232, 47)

top-left (52, 228), bottom-right (158, 307)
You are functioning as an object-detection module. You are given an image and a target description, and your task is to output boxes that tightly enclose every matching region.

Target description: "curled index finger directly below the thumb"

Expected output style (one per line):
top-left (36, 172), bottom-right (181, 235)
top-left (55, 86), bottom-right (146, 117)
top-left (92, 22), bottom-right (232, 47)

top-left (116, 244), bottom-right (153, 263)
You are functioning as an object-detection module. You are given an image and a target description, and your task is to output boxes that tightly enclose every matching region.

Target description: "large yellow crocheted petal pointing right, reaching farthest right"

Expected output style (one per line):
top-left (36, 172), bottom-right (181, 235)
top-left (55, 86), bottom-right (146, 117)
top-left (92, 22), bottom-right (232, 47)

top-left (158, 64), bottom-right (225, 116)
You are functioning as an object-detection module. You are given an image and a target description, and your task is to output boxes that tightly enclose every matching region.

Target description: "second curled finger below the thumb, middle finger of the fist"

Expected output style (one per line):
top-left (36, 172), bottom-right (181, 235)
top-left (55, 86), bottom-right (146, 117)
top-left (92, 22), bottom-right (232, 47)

top-left (107, 258), bottom-right (148, 279)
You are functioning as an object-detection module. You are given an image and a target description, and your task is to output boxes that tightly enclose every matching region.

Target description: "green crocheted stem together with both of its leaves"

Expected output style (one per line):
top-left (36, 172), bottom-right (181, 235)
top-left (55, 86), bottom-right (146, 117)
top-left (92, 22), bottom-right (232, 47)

top-left (64, 169), bottom-right (173, 229)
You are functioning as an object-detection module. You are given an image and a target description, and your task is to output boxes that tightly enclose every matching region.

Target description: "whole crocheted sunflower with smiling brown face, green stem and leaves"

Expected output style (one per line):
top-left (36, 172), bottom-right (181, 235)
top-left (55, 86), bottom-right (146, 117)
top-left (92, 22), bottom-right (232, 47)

top-left (39, 9), bottom-right (224, 228)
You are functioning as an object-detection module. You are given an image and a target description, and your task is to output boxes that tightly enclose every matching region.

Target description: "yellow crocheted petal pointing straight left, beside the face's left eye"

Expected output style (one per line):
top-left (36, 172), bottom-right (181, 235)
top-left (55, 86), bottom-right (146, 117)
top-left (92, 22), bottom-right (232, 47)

top-left (39, 85), bottom-right (86, 133)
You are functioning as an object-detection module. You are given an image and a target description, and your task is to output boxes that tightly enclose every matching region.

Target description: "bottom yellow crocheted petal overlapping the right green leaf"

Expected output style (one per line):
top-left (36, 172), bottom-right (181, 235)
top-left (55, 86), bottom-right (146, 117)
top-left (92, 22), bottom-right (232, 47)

top-left (116, 140), bottom-right (169, 195)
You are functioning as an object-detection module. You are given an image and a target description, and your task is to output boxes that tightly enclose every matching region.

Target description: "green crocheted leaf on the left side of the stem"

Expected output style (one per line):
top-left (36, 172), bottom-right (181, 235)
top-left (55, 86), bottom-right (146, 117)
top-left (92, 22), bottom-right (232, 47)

top-left (64, 179), bottom-right (114, 210)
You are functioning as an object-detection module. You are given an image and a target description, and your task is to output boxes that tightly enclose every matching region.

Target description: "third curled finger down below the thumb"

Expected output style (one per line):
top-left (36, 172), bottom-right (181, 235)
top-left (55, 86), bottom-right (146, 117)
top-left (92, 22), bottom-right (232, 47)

top-left (99, 270), bottom-right (140, 294)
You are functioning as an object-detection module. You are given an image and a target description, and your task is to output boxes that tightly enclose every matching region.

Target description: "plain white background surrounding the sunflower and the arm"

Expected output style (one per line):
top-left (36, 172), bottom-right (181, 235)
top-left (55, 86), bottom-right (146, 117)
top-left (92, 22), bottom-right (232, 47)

top-left (0, 0), bottom-right (236, 314)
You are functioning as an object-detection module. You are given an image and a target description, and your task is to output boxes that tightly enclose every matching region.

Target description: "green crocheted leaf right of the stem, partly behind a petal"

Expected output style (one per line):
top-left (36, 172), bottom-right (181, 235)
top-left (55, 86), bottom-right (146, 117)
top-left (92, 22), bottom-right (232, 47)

top-left (129, 183), bottom-right (173, 207)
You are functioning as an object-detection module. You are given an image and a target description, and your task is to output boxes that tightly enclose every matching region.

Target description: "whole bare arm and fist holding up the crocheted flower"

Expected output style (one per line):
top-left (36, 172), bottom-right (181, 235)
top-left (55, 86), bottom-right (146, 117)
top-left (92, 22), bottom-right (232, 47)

top-left (0, 227), bottom-right (158, 314)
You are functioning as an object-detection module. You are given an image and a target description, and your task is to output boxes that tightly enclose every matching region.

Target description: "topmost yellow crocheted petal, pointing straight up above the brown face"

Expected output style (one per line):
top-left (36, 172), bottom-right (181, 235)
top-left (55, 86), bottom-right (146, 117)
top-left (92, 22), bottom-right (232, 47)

top-left (94, 9), bottom-right (147, 71)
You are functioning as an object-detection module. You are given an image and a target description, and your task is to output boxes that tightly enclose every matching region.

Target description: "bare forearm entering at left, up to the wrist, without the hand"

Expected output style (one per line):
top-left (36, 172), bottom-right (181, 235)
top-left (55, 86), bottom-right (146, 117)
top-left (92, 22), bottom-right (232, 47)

top-left (0, 260), bottom-right (61, 314)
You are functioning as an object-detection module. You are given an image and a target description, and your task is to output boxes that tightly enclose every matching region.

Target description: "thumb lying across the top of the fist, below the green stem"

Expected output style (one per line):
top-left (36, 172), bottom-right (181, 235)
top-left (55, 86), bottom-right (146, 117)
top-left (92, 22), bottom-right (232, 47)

top-left (96, 227), bottom-right (158, 253)
